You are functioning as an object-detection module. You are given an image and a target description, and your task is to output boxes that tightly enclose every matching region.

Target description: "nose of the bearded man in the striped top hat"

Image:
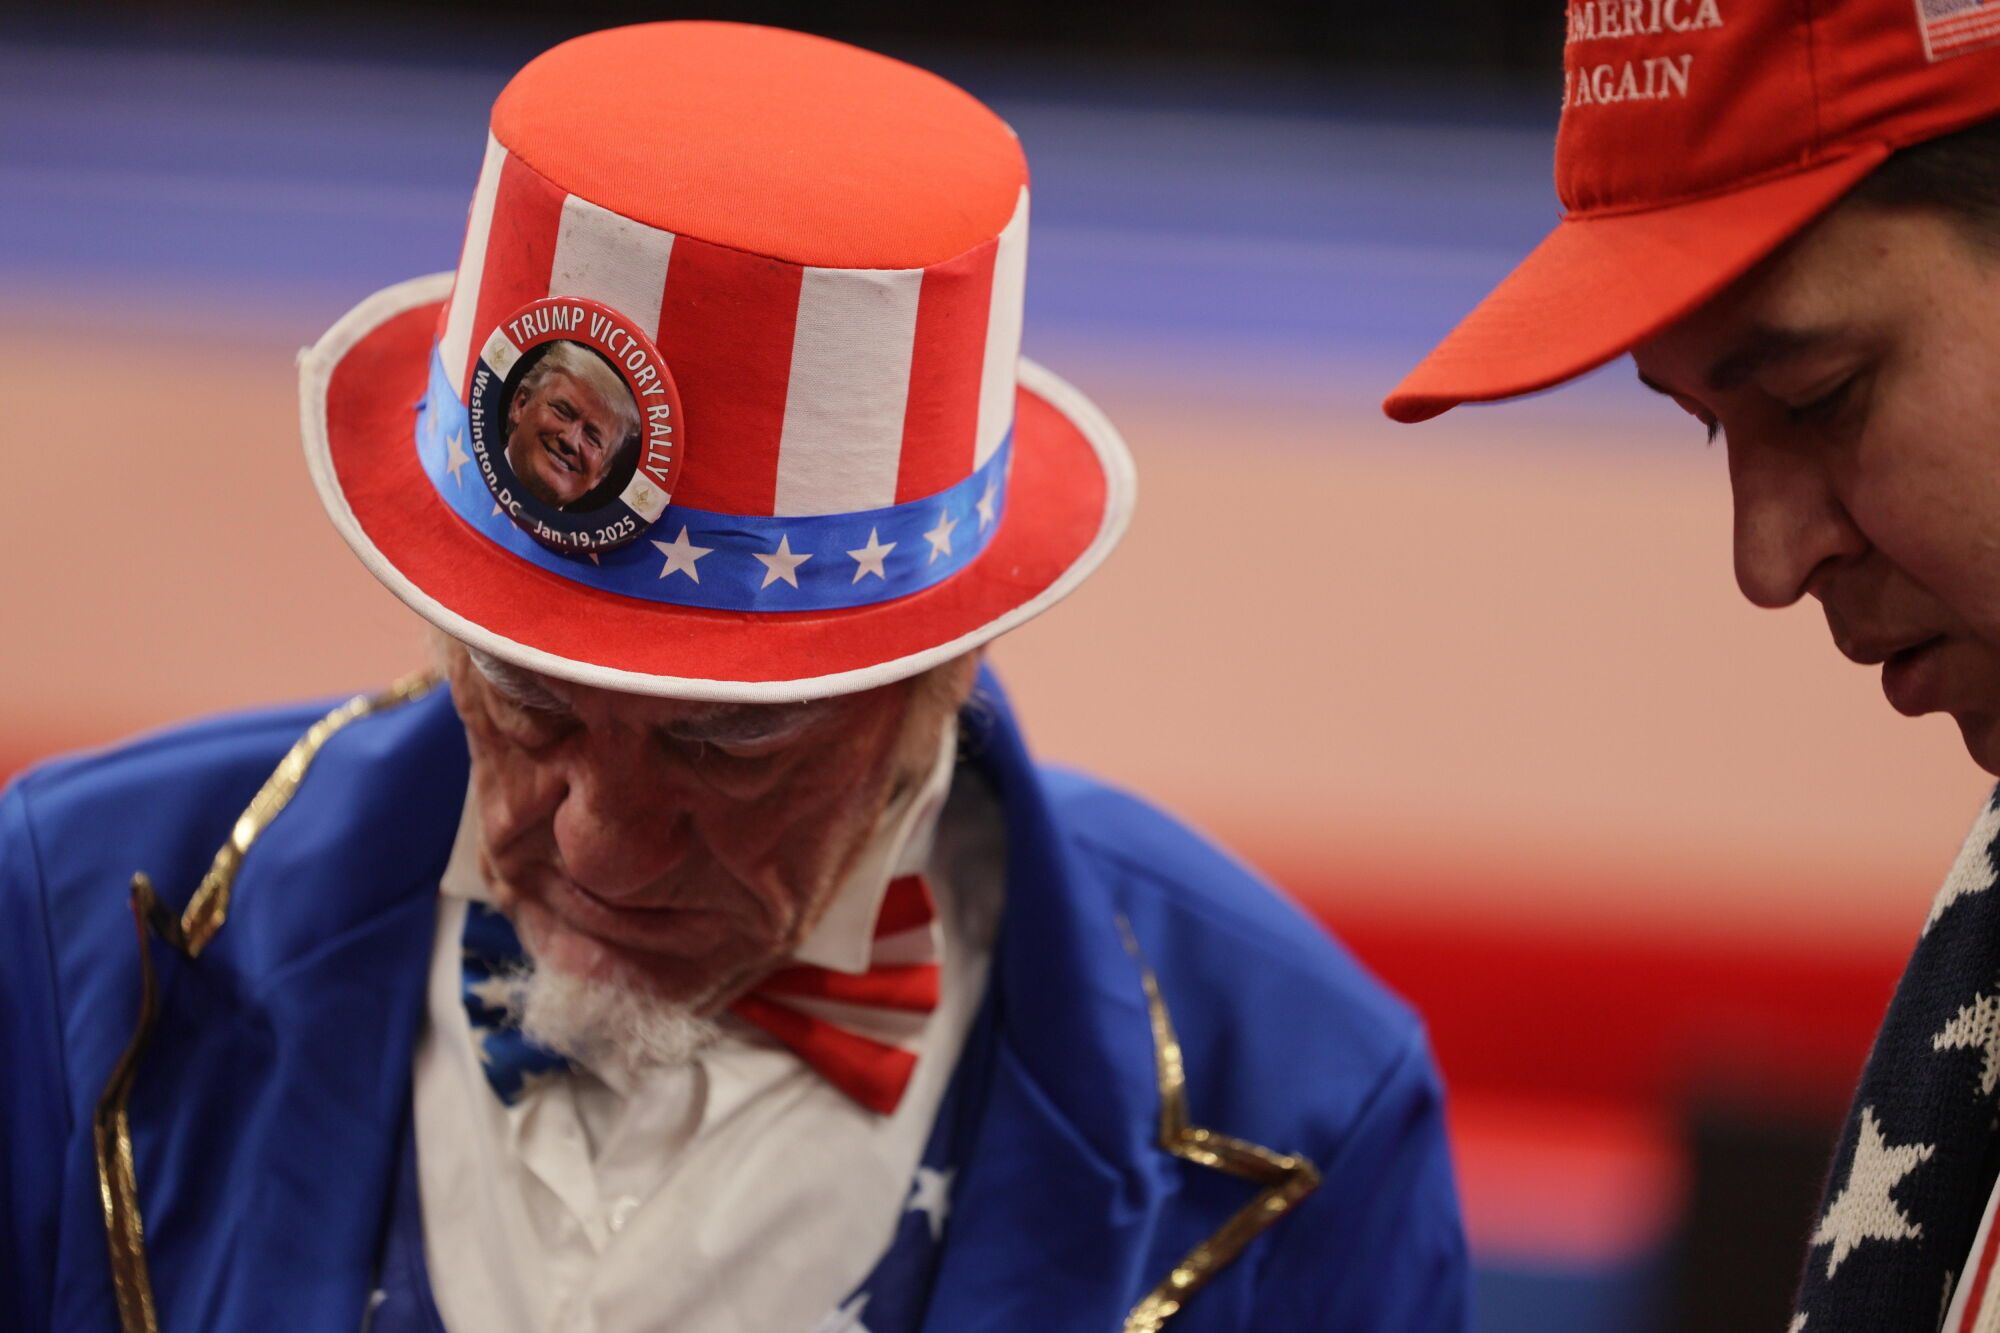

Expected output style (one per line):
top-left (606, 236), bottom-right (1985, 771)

top-left (554, 745), bottom-right (690, 907)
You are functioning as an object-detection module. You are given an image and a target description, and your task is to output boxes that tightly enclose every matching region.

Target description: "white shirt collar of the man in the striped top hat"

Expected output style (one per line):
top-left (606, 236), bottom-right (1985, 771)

top-left (438, 717), bottom-right (958, 975)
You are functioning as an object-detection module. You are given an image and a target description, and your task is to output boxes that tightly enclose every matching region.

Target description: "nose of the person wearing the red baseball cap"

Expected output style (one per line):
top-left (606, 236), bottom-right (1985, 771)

top-left (1730, 436), bottom-right (1868, 608)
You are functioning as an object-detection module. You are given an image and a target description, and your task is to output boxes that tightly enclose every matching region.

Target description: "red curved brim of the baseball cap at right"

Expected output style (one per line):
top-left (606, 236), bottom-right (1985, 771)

top-left (1382, 144), bottom-right (1890, 422)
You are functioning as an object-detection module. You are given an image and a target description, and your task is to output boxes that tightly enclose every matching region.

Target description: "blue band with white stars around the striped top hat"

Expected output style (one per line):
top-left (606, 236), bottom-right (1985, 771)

top-left (416, 350), bottom-right (1014, 610)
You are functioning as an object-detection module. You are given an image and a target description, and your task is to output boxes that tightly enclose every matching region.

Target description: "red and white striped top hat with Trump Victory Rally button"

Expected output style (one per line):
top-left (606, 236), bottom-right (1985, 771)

top-left (300, 22), bottom-right (1134, 701)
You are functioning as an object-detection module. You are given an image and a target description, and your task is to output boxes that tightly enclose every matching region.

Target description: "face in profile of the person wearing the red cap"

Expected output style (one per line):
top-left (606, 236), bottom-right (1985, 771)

top-left (1634, 204), bottom-right (2000, 773)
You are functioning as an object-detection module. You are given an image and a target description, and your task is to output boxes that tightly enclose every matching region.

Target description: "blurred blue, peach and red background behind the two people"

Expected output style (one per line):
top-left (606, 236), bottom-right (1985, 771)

top-left (0, 0), bottom-right (1986, 1333)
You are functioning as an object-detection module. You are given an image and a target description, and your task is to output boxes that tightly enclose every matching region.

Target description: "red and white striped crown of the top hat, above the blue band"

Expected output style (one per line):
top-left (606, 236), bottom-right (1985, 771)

top-left (438, 22), bottom-right (1028, 516)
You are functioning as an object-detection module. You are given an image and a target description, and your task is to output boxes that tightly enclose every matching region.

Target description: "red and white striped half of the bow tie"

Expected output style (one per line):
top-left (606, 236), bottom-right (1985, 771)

top-left (730, 875), bottom-right (938, 1115)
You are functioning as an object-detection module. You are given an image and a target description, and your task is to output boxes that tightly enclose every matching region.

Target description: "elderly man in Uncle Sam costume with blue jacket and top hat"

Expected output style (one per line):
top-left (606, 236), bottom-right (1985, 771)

top-left (0, 24), bottom-right (1466, 1333)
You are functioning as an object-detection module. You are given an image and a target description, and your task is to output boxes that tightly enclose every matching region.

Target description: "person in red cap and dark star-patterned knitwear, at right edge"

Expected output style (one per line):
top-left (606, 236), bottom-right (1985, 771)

top-left (1384, 0), bottom-right (2000, 1333)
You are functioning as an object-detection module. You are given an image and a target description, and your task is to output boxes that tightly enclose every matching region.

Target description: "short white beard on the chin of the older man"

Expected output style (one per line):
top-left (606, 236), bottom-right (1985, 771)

top-left (508, 912), bottom-right (722, 1075)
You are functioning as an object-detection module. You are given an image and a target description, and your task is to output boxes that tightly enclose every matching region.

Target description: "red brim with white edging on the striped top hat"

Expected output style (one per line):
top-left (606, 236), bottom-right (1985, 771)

top-left (300, 274), bottom-right (1136, 703)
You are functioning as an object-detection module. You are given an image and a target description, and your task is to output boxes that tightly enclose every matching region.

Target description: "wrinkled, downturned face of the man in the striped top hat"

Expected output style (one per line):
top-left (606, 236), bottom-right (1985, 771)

top-left (446, 644), bottom-right (974, 1013)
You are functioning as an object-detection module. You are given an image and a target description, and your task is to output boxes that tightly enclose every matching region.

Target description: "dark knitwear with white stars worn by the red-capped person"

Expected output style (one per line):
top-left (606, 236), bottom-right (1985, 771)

top-left (1790, 791), bottom-right (2000, 1333)
